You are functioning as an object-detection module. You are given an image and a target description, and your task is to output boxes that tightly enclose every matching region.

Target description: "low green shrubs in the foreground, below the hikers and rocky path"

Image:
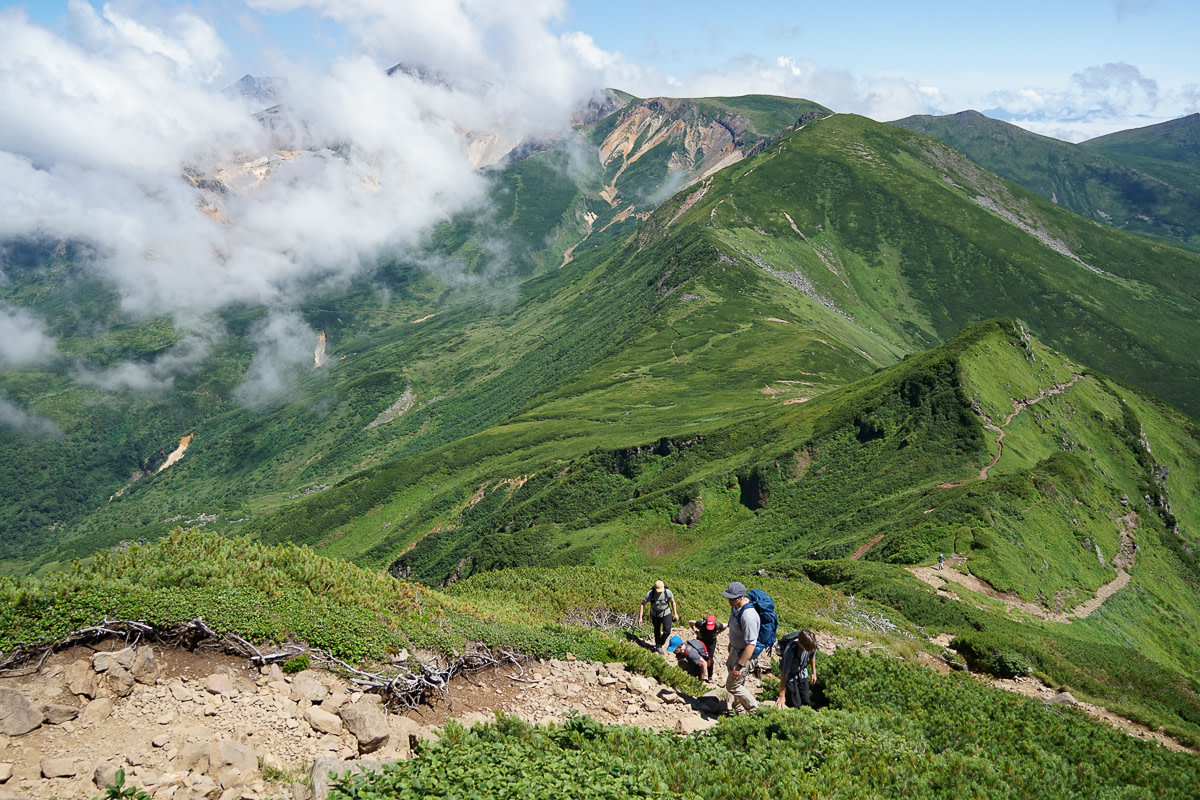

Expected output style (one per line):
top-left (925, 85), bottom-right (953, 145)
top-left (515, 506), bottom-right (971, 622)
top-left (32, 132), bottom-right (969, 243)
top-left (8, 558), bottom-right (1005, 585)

top-left (332, 651), bottom-right (1200, 799)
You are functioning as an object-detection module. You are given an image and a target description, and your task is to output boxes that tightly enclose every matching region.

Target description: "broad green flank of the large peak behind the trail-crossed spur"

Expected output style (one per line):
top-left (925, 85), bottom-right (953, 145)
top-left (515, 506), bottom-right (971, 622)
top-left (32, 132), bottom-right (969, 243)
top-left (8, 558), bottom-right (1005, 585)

top-left (667, 115), bottom-right (1200, 422)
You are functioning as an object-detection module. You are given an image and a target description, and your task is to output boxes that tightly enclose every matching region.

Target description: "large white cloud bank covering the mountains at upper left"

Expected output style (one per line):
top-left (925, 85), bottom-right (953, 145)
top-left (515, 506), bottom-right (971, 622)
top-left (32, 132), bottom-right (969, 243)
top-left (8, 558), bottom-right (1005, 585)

top-left (0, 0), bottom-right (599, 397)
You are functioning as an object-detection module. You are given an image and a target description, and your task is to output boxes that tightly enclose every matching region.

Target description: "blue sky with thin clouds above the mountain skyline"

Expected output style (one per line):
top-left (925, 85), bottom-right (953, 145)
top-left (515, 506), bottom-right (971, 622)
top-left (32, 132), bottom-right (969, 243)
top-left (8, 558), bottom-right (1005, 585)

top-left (11, 0), bottom-right (1200, 140)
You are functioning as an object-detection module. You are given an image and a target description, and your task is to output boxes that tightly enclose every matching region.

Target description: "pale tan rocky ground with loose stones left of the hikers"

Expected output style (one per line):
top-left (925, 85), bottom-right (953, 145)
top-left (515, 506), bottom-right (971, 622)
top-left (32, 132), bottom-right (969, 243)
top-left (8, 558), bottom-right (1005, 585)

top-left (0, 640), bottom-right (748, 800)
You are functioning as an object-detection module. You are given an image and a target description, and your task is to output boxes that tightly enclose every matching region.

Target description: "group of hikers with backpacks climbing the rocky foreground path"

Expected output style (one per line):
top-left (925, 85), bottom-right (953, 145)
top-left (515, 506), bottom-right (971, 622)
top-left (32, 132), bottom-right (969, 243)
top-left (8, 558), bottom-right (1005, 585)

top-left (637, 581), bottom-right (817, 714)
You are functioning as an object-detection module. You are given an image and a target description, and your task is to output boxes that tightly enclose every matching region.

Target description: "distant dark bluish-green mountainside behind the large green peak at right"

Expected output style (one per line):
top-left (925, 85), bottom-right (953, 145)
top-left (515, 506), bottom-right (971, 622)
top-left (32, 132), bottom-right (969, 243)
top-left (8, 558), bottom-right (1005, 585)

top-left (892, 112), bottom-right (1200, 249)
